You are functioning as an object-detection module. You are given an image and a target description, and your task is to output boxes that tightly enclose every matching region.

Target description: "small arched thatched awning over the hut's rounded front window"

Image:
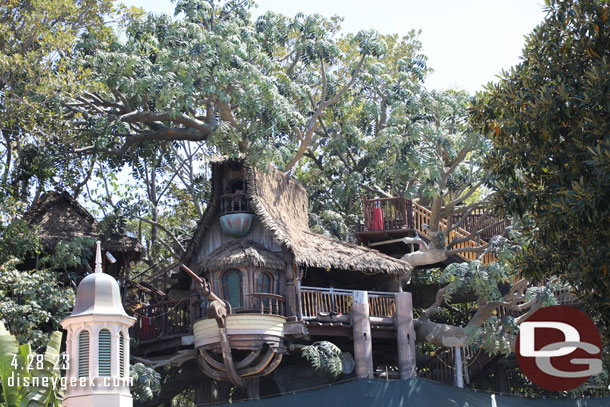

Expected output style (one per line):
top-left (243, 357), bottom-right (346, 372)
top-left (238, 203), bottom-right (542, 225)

top-left (197, 240), bottom-right (286, 272)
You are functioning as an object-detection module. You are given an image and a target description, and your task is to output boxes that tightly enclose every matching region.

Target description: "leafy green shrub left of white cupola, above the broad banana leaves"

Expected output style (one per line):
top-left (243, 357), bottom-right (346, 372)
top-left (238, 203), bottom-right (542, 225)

top-left (0, 260), bottom-right (74, 349)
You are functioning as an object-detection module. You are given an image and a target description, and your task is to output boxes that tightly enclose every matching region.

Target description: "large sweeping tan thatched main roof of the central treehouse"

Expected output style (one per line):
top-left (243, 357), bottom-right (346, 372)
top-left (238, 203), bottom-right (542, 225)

top-left (184, 160), bottom-right (411, 274)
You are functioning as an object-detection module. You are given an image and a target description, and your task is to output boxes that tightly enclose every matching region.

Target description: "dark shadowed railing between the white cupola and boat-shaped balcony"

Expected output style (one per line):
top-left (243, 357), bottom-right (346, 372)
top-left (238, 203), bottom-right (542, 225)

top-left (130, 300), bottom-right (191, 341)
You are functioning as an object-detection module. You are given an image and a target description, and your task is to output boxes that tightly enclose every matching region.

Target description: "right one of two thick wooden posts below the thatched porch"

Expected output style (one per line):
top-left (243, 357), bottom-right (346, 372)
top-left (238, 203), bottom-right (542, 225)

top-left (394, 292), bottom-right (417, 380)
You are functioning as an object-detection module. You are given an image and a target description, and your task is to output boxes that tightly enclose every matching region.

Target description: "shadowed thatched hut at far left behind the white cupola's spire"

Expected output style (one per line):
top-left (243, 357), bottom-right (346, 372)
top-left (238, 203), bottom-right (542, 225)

top-left (23, 191), bottom-right (143, 278)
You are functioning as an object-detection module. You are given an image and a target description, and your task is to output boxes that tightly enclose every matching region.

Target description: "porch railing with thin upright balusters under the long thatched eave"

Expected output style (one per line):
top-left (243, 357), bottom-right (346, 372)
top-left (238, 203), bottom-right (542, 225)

top-left (301, 286), bottom-right (396, 319)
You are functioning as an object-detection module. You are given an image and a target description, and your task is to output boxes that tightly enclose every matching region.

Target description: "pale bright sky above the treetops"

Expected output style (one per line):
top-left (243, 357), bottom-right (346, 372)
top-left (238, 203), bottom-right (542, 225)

top-left (121, 0), bottom-right (545, 93)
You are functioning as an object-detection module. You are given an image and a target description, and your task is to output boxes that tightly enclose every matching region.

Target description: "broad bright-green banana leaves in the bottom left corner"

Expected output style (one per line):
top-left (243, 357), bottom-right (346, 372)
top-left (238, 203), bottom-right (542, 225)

top-left (0, 322), bottom-right (63, 407)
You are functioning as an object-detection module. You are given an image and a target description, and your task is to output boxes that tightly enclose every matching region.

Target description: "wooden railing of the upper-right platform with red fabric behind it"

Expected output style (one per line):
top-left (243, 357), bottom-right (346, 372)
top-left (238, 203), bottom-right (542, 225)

top-left (362, 197), bottom-right (413, 231)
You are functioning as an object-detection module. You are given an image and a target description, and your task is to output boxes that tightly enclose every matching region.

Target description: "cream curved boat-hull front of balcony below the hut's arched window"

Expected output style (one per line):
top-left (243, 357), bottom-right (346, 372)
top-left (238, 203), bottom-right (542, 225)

top-left (193, 314), bottom-right (286, 349)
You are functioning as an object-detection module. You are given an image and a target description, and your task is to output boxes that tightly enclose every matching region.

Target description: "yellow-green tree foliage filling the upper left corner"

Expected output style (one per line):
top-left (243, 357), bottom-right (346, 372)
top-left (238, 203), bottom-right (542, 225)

top-left (0, 0), bottom-right (124, 200)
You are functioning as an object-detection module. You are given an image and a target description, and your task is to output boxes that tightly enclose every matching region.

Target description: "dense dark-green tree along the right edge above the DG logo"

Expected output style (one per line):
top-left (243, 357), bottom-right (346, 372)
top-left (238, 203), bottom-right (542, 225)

top-left (471, 0), bottom-right (610, 336)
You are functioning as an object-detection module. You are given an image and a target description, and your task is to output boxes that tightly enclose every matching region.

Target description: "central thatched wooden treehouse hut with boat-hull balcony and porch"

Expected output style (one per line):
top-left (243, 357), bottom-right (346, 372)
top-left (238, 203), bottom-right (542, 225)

top-left (164, 159), bottom-right (411, 395)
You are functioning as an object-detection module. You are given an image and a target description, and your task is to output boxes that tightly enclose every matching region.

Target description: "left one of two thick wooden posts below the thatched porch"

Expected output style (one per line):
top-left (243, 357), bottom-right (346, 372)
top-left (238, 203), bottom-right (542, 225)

top-left (350, 291), bottom-right (373, 378)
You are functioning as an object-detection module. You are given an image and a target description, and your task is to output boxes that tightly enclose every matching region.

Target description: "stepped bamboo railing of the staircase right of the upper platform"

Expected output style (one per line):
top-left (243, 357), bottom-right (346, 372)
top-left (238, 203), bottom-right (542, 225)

top-left (413, 202), bottom-right (496, 264)
